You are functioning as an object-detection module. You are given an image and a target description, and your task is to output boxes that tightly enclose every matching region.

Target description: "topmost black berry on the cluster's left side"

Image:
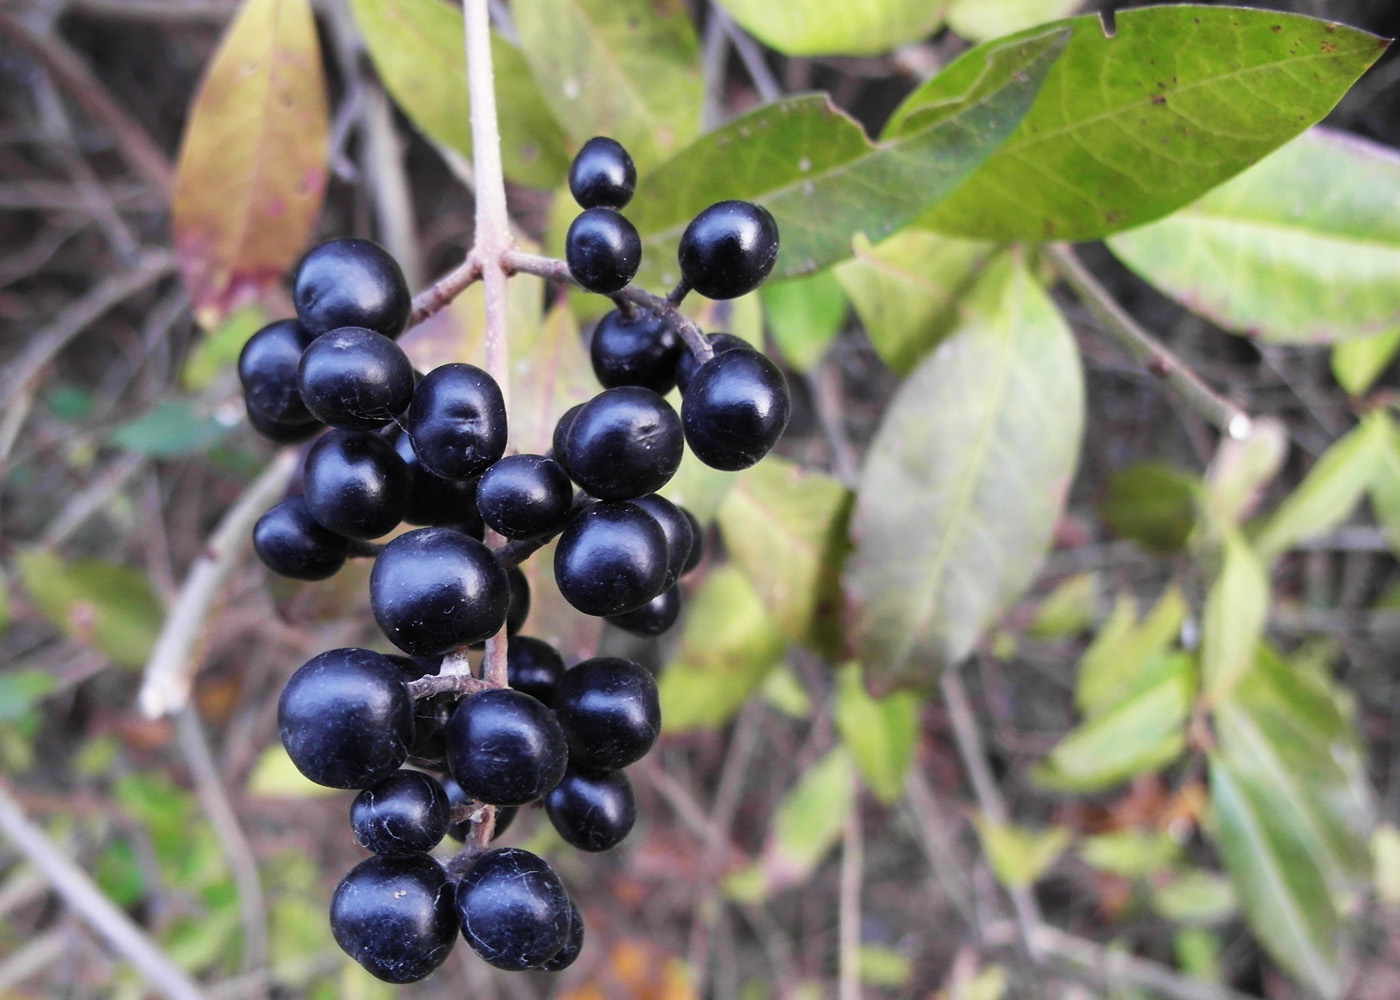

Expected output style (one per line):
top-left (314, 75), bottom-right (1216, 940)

top-left (291, 238), bottom-right (412, 338)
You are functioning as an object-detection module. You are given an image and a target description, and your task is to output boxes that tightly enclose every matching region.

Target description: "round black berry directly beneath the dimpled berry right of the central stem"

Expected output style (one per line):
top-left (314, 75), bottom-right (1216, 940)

top-left (554, 503), bottom-right (666, 618)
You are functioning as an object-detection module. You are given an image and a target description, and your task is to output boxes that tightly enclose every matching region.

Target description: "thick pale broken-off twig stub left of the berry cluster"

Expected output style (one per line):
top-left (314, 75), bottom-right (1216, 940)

top-left (137, 448), bottom-right (297, 718)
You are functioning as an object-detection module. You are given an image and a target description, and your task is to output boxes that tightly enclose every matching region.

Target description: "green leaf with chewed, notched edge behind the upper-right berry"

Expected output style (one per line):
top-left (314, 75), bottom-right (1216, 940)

top-left (627, 31), bottom-right (1064, 287)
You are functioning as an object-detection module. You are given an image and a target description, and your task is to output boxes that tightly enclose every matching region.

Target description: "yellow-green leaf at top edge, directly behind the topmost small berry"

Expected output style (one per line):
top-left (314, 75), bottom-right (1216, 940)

top-left (511, 0), bottom-right (704, 169)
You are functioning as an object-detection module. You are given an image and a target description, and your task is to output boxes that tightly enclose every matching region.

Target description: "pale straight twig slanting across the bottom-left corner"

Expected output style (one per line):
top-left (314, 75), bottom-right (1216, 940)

top-left (0, 782), bottom-right (204, 1000)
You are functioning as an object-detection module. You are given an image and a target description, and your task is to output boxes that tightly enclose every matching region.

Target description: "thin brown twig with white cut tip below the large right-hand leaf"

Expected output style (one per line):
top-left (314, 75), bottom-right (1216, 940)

top-left (1043, 244), bottom-right (1252, 440)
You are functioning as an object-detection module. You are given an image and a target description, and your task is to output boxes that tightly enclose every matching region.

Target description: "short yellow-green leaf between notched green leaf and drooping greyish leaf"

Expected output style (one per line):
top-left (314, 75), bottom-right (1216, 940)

top-left (836, 230), bottom-right (1001, 375)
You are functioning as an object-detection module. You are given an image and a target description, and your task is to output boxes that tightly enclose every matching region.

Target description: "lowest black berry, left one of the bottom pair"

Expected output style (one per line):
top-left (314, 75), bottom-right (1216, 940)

top-left (330, 854), bottom-right (458, 983)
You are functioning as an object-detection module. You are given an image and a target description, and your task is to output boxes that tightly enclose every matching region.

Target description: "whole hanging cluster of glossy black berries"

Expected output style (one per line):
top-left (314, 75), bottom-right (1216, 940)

top-left (238, 139), bottom-right (790, 983)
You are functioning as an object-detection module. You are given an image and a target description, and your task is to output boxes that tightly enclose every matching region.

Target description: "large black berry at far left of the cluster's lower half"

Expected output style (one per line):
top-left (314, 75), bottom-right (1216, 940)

top-left (277, 647), bottom-right (413, 789)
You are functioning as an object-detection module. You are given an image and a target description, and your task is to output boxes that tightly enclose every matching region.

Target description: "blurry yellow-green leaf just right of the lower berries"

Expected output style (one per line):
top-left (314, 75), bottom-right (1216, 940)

top-left (658, 566), bottom-right (784, 732)
